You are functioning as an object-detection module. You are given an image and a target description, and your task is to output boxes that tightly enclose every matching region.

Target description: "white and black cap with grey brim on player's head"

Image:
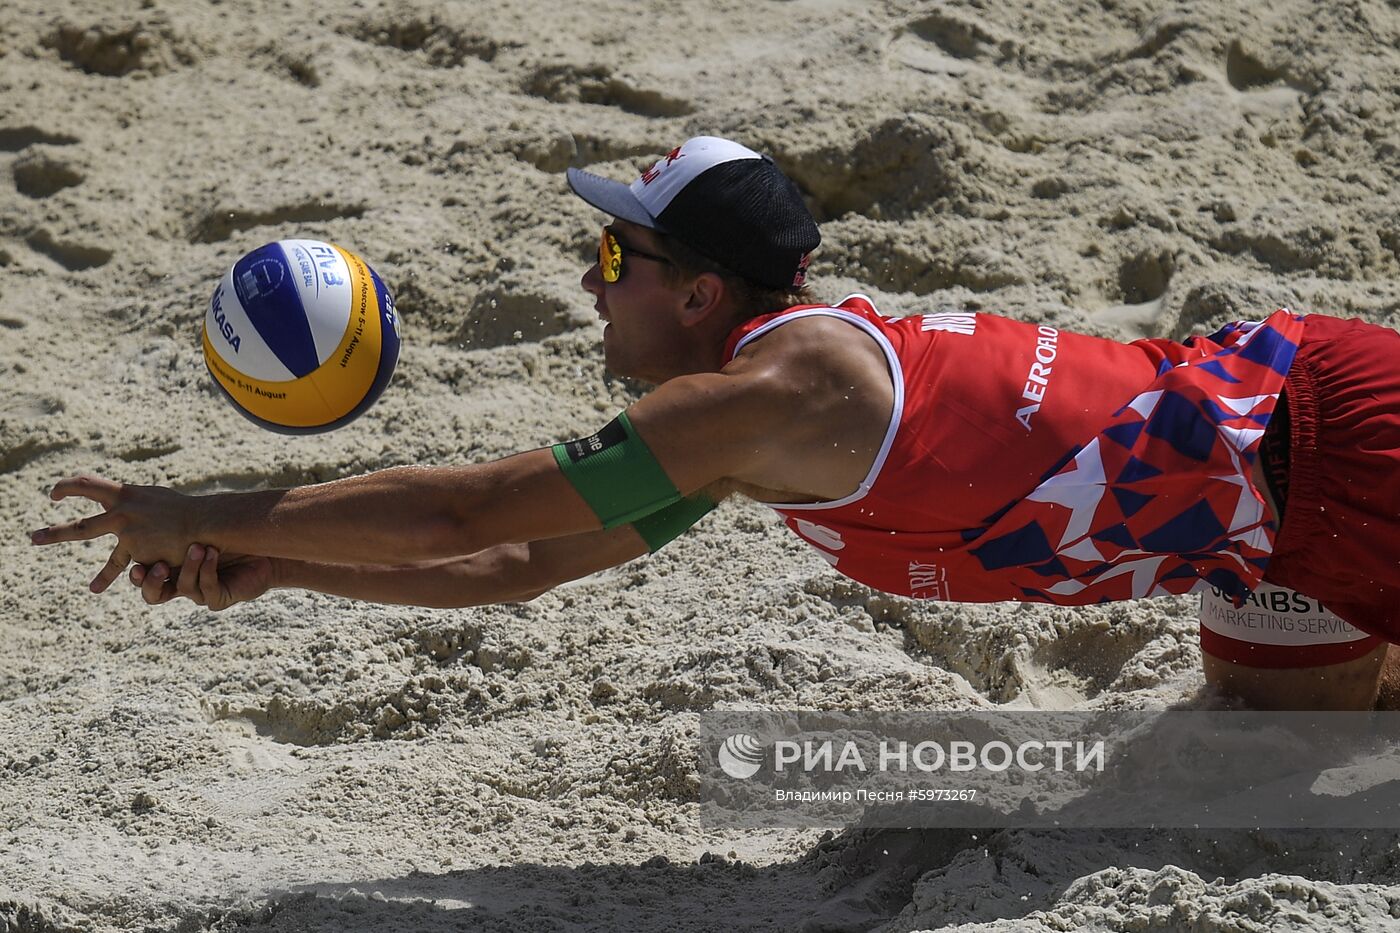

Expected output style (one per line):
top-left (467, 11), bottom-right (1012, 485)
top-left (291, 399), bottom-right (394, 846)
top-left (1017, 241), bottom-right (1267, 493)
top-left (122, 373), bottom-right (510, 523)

top-left (568, 136), bottom-right (822, 289)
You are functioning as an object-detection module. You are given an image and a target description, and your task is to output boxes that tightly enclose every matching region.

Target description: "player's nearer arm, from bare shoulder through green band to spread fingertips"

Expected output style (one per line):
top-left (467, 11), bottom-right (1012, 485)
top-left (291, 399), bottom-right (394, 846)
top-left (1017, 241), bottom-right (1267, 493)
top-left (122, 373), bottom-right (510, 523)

top-left (31, 348), bottom-right (806, 593)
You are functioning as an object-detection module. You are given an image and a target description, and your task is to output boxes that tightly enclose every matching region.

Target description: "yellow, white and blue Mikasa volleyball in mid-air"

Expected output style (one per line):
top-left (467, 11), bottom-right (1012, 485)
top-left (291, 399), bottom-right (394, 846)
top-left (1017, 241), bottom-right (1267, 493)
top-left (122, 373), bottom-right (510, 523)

top-left (203, 240), bottom-right (399, 434)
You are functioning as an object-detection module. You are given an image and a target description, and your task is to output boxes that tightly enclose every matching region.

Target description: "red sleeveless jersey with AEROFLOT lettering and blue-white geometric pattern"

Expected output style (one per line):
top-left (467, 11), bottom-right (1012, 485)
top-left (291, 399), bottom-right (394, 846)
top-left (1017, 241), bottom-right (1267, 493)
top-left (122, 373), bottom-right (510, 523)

top-left (724, 296), bottom-right (1302, 605)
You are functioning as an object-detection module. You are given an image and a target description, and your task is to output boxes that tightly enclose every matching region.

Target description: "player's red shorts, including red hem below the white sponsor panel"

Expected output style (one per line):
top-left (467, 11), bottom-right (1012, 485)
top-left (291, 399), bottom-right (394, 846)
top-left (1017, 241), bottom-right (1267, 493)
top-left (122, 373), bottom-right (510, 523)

top-left (1201, 314), bottom-right (1400, 667)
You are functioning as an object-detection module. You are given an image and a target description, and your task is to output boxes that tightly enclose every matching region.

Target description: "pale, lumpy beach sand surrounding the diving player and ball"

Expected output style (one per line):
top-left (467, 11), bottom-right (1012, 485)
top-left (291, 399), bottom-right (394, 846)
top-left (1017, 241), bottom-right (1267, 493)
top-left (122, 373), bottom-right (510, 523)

top-left (8, 0), bottom-right (1400, 933)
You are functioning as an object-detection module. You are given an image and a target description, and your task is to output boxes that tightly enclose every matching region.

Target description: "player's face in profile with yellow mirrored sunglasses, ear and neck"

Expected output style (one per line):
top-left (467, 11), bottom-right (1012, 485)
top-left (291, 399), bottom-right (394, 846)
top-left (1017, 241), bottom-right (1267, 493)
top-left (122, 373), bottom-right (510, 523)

top-left (581, 220), bottom-right (687, 384)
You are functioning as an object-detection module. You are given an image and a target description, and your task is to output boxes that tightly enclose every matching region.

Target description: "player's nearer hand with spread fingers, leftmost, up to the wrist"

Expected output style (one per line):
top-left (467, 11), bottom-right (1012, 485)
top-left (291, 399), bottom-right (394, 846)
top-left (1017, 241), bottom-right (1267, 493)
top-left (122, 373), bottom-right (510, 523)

top-left (29, 476), bottom-right (196, 593)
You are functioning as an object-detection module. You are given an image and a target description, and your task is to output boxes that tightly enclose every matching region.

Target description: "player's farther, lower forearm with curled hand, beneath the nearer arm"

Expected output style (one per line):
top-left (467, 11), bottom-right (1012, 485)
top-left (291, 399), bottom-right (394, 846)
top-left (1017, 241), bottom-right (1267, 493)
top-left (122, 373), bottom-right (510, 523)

top-left (130, 525), bottom-right (648, 612)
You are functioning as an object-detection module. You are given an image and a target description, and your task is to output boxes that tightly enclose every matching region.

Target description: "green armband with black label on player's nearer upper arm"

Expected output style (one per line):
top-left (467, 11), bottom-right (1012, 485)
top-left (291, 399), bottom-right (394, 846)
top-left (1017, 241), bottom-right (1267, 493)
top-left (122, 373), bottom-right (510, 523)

top-left (552, 412), bottom-right (680, 528)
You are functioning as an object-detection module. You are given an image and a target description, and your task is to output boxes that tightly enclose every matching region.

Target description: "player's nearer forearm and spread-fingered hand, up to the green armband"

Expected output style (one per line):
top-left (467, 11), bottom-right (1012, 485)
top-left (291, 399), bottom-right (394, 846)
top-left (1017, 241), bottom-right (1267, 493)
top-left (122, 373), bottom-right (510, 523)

top-left (31, 450), bottom-right (599, 593)
